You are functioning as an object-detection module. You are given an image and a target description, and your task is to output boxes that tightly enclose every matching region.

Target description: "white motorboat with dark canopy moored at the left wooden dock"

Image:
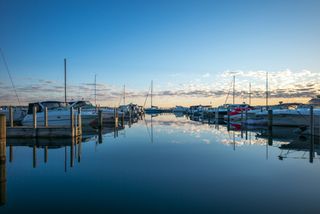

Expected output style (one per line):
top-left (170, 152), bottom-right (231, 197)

top-left (22, 101), bottom-right (97, 127)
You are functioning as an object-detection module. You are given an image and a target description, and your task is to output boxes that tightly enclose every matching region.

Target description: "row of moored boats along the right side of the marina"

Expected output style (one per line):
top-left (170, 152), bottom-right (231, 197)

top-left (172, 98), bottom-right (320, 135)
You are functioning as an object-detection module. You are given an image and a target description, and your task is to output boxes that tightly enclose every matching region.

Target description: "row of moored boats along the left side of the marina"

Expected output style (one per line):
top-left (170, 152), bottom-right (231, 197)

top-left (0, 100), bottom-right (143, 127)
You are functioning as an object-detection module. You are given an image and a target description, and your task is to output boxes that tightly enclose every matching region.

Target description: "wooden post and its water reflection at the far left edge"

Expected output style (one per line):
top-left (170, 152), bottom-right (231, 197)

top-left (0, 114), bottom-right (7, 206)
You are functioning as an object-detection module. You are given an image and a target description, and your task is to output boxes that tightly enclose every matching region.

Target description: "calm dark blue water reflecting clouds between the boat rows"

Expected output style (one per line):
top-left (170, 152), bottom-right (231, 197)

top-left (0, 115), bottom-right (320, 214)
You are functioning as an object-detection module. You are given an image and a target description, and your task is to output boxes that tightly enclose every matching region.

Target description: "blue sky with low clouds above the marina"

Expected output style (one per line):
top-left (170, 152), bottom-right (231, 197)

top-left (0, 0), bottom-right (320, 107)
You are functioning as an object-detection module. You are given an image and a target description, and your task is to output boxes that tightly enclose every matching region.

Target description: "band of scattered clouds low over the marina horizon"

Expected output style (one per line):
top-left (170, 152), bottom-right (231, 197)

top-left (0, 69), bottom-right (320, 106)
